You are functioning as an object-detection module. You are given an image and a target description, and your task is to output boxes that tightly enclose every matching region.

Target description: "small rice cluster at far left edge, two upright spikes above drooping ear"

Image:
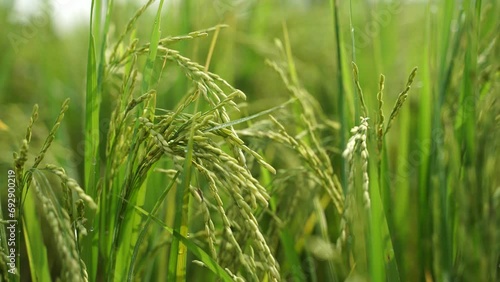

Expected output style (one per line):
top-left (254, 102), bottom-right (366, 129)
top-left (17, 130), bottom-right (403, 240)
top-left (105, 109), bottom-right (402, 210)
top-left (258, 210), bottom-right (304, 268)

top-left (7, 100), bottom-right (97, 281)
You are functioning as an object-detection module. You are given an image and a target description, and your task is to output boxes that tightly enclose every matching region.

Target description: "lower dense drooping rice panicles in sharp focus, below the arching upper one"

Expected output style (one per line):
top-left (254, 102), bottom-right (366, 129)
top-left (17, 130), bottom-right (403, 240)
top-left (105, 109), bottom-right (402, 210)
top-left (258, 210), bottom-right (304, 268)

top-left (135, 104), bottom-right (279, 280)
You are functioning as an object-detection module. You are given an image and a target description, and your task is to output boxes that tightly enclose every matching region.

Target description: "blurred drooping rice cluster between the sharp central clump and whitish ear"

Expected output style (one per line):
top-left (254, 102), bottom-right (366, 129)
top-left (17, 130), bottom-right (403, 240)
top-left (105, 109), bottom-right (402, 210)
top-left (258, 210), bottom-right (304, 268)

top-left (238, 45), bottom-right (344, 280)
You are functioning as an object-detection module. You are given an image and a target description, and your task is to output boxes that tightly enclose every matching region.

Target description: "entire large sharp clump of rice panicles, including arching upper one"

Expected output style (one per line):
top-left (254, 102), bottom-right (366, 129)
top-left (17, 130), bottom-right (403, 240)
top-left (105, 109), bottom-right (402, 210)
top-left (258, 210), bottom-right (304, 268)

top-left (103, 8), bottom-right (280, 281)
